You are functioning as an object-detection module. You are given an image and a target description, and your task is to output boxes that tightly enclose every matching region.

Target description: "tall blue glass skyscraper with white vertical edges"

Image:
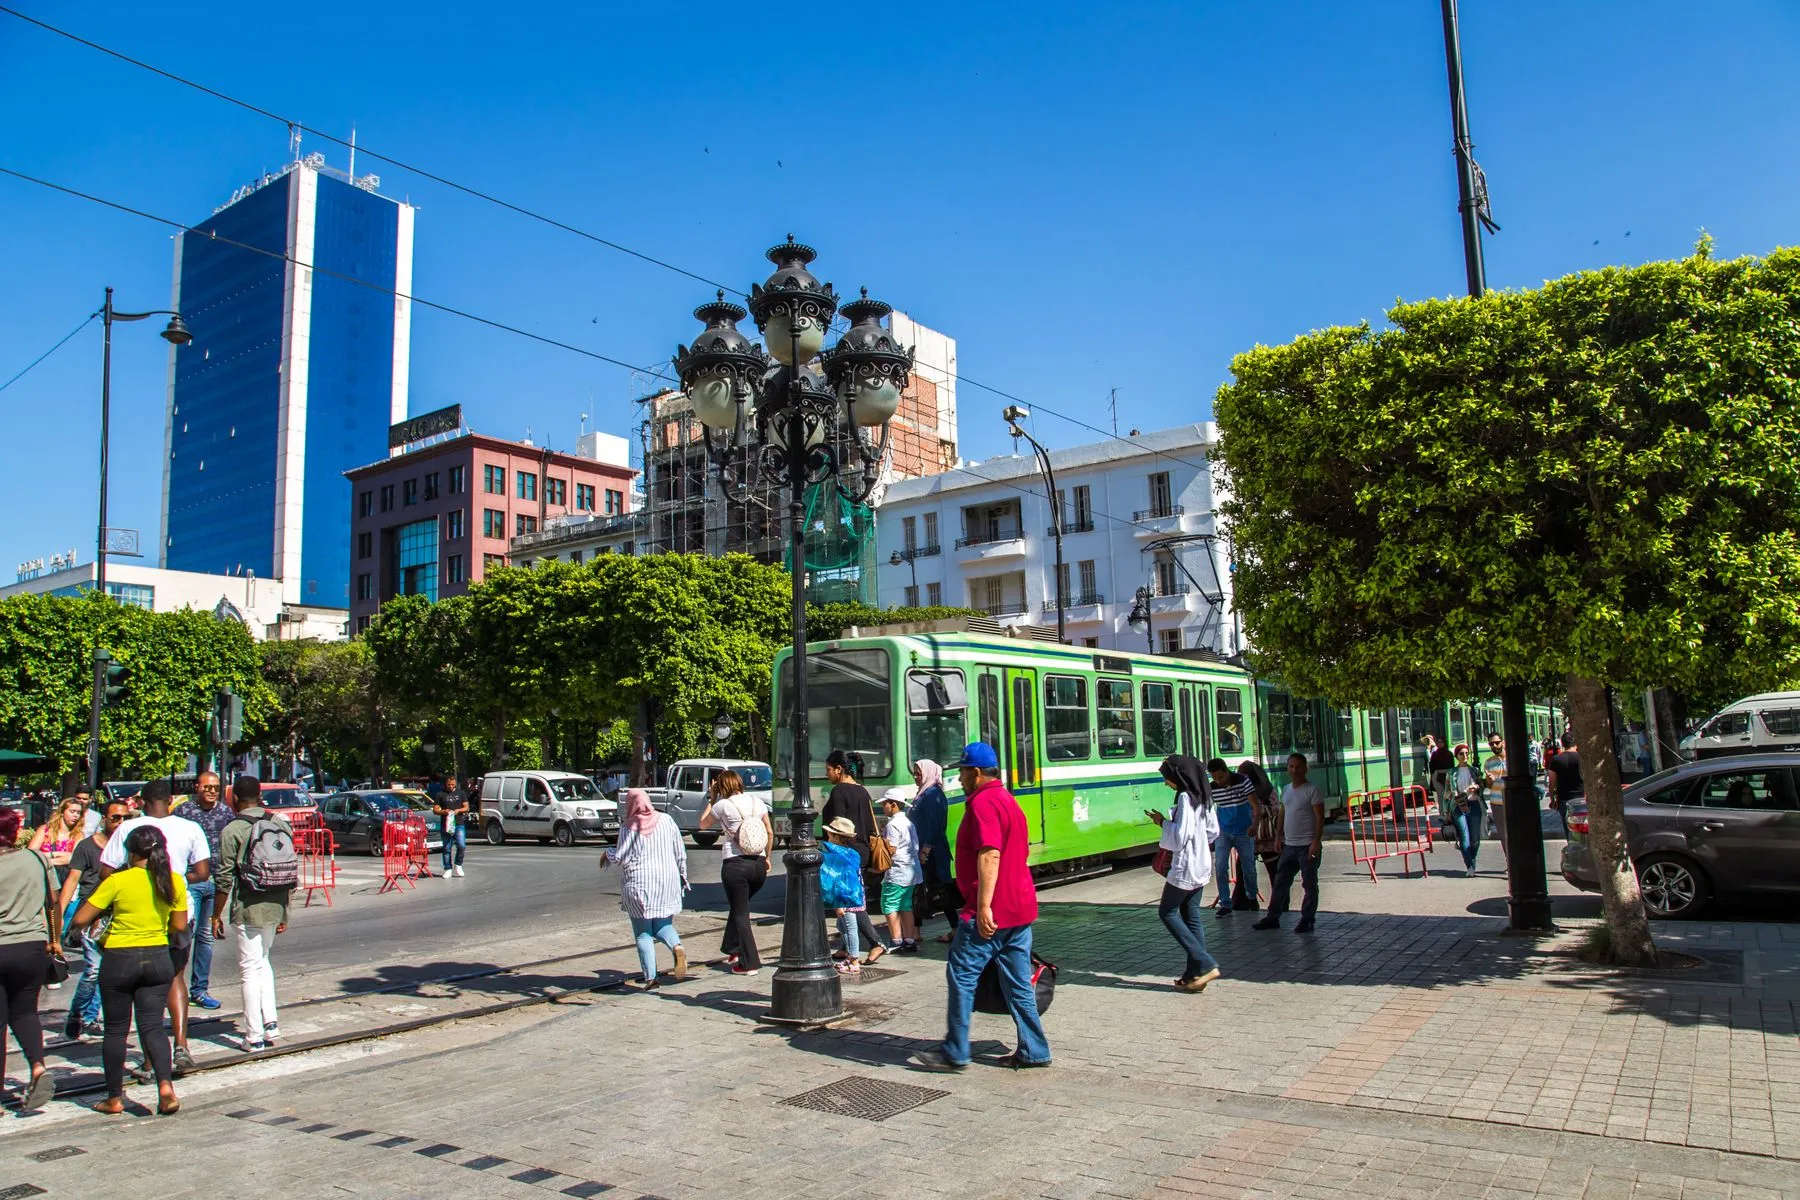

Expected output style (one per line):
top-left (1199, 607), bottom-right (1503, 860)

top-left (160, 155), bottom-right (414, 608)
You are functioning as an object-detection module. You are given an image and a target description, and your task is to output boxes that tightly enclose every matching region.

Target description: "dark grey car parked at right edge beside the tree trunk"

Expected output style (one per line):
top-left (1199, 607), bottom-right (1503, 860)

top-left (1562, 752), bottom-right (1800, 918)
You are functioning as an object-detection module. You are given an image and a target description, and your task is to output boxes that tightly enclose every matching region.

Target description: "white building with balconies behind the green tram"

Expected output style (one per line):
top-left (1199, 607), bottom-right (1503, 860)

top-left (875, 423), bottom-right (1240, 655)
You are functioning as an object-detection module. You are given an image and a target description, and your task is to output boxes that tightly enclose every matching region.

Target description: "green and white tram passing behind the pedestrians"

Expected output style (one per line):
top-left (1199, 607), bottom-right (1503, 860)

top-left (770, 630), bottom-right (1552, 873)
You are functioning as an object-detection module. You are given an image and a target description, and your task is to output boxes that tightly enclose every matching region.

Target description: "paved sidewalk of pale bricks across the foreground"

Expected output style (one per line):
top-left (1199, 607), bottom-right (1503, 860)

top-left (0, 845), bottom-right (1800, 1200)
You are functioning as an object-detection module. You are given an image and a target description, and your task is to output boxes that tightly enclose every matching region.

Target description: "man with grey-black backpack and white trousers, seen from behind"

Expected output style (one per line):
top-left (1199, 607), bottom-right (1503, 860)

top-left (212, 775), bottom-right (301, 1052)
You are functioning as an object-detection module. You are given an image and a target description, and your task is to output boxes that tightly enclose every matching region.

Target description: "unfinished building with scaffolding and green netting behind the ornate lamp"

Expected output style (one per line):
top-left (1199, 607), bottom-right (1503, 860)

top-left (639, 313), bottom-right (956, 604)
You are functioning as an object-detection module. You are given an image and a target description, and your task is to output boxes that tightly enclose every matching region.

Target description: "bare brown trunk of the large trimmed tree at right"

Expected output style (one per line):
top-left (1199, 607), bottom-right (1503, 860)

top-left (1568, 675), bottom-right (1656, 966)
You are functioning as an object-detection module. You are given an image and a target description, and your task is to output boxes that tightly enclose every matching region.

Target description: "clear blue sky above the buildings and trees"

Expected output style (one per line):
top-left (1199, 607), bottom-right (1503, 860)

top-left (0, 0), bottom-right (1800, 581)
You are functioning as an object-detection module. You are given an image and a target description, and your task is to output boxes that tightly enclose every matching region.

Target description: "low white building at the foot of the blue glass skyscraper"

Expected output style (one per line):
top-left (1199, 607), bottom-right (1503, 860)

top-left (0, 552), bottom-right (349, 642)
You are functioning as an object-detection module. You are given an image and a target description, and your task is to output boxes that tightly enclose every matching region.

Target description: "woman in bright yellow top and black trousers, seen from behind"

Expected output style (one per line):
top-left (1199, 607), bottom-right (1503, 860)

top-left (74, 826), bottom-right (187, 1117)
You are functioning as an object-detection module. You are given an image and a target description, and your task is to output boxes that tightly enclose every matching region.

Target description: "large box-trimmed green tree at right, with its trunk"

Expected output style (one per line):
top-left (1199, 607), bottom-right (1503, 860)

top-left (1217, 245), bottom-right (1800, 963)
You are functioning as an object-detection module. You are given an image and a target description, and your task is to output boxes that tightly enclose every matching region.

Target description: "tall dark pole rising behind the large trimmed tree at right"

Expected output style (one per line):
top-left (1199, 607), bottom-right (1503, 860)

top-left (1442, 0), bottom-right (1553, 932)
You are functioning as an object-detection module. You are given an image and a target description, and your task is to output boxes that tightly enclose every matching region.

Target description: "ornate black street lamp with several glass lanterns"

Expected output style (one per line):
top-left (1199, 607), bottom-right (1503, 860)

top-left (675, 234), bottom-right (913, 1025)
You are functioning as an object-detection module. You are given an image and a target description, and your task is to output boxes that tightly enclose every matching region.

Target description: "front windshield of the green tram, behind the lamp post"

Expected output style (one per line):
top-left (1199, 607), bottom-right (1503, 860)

top-left (774, 649), bottom-right (895, 779)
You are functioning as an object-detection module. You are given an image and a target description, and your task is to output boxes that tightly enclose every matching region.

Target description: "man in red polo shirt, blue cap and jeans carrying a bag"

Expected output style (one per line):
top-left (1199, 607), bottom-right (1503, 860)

top-left (913, 741), bottom-right (1049, 1070)
